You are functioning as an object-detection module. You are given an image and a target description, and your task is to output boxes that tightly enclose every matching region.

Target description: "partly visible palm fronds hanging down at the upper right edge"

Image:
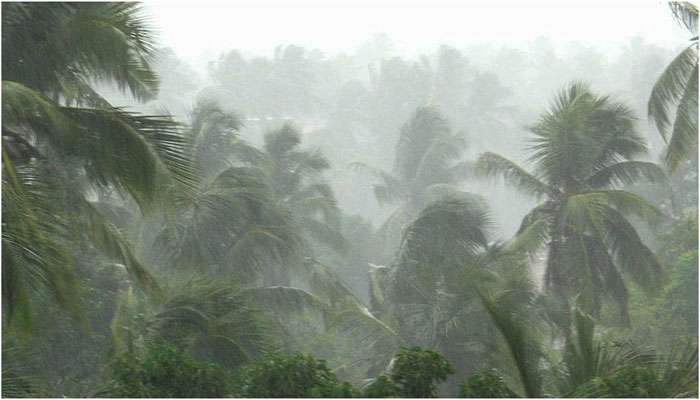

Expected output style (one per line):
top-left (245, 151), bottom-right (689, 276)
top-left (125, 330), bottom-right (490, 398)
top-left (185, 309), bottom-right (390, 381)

top-left (648, 1), bottom-right (698, 171)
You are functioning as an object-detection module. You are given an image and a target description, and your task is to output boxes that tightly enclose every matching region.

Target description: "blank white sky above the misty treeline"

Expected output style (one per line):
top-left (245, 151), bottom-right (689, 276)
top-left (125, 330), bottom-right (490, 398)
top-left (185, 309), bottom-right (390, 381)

top-left (145, 0), bottom-right (688, 65)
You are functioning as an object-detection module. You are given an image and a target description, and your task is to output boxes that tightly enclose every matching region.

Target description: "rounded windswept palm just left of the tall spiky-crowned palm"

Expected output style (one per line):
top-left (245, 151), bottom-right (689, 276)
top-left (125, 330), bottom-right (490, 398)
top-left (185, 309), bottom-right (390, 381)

top-left (370, 194), bottom-right (548, 395)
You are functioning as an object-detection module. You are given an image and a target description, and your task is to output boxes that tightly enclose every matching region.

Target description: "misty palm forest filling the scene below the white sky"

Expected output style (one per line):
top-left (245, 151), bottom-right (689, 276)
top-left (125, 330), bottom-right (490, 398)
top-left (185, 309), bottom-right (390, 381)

top-left (2, 2), bottom-right (698, 398)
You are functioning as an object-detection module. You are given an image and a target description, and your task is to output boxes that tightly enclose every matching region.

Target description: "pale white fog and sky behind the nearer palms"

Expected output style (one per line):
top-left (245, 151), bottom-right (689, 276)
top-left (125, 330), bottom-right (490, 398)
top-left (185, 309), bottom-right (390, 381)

top-left (100, 1), bottom-right (685, 237)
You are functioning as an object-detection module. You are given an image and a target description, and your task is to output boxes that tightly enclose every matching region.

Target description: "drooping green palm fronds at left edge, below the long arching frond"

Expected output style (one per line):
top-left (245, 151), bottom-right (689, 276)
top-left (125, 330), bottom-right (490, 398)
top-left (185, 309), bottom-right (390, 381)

top-left (2, 153), bottom-right (78, 328)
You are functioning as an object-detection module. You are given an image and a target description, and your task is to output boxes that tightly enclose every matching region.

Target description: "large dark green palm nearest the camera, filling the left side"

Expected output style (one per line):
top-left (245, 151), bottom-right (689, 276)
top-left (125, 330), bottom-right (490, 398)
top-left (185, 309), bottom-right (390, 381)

top-left (2, 3), bottom-right (192, 326)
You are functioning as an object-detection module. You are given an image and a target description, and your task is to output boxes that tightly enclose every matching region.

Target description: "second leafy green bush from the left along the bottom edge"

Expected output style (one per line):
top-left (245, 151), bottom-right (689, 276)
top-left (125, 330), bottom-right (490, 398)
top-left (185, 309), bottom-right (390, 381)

top-left (237, 354), bottom-right (355, 398)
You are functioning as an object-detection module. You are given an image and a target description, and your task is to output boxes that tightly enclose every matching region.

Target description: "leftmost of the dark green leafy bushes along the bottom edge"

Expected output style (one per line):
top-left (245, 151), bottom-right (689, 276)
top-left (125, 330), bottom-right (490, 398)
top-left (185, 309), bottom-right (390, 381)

top-left (109, 344), bottom-right (228, 397)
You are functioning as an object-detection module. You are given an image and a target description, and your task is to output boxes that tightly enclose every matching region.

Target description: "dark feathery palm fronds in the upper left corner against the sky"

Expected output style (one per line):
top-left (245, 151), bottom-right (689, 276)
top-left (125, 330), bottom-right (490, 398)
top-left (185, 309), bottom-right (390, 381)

top-left (2, 3), bottom-right (158, 100)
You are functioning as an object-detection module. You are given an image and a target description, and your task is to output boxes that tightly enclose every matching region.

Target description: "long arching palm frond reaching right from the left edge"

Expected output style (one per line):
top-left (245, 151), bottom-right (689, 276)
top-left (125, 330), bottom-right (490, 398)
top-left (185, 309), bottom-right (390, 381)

top-left (3, 81), bottom-right (193, 207)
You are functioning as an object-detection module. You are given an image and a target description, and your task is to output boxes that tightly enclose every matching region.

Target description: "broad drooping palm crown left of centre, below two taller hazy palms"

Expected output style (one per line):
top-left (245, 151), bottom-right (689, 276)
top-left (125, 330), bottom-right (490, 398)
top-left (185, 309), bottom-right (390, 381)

top-left (154, 167), bottom-right (302, 279)
